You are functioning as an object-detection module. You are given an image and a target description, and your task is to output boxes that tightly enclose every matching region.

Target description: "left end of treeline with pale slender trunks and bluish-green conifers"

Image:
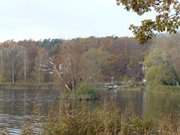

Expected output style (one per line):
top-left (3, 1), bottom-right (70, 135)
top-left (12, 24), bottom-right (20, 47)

top-left (0, 39), bottom-right (62, 83)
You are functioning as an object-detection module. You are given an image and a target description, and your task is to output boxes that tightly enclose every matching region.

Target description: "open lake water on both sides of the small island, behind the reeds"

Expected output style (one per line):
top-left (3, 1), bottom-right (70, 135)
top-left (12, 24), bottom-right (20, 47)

top-left (0, 90), bottom-right (180, 135)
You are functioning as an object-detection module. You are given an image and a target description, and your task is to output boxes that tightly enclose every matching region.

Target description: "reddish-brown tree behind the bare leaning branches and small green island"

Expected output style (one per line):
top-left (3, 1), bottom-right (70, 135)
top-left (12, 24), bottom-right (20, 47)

top-left (54, 40), bottom-right (84, 90)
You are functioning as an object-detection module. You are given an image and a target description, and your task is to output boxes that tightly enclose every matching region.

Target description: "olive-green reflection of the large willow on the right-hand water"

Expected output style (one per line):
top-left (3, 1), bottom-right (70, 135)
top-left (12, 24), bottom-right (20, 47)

top-left (144, 91), bottom-right (180, 119)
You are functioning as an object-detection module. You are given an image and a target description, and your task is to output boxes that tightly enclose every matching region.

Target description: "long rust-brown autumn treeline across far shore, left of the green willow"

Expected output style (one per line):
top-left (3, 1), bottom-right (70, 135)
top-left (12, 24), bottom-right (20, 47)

top-left (0, 37), bottom-right (149, 87)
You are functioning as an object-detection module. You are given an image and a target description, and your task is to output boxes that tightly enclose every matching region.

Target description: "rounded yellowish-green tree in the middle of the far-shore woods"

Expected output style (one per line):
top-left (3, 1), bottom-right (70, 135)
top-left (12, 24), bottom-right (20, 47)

top-left (81, 47), bottom-right (111, 82)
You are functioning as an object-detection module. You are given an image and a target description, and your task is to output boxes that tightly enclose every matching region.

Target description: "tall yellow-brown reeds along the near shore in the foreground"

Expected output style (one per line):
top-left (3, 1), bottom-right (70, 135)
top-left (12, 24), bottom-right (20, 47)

top-left (40, 102), bottom-right (178, 135)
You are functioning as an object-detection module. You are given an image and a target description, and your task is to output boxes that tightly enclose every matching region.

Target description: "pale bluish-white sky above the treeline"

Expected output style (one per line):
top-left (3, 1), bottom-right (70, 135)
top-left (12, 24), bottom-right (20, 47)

top-left (0, 0), bottom-right (153, 41)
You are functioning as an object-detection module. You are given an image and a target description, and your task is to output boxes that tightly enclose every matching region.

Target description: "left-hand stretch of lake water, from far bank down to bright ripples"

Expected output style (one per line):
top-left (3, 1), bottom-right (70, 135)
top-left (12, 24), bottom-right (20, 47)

top-left (0, 90), bottom-right (59, 134)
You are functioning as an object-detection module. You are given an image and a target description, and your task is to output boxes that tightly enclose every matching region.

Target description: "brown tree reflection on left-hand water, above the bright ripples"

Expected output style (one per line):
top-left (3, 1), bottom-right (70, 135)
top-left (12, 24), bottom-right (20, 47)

top-left (0, 90), bottom-right (59, 116)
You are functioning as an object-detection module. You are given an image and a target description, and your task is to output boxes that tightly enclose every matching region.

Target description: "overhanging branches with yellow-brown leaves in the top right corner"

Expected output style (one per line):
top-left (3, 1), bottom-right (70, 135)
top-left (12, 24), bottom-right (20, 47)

top-left (116, 0), bottom-right (180, 43)
